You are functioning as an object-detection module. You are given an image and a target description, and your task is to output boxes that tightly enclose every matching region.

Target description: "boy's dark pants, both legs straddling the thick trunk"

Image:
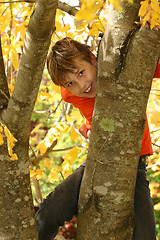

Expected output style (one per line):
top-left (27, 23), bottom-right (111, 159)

top-left (36, 158), bottom-right (156, 240)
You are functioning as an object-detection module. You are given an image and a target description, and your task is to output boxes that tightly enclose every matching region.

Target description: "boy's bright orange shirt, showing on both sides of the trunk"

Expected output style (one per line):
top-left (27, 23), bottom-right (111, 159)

top-left (61, 64), bottom-right (160, 155)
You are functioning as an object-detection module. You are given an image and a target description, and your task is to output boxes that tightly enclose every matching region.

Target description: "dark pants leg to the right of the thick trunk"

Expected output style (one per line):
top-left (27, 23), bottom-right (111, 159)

top-left (133, 158), bottom-right (156, 240)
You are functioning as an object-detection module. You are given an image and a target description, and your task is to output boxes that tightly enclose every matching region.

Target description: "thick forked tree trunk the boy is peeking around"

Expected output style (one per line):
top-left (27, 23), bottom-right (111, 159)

top-left (77, 2), bottom-right (160, 240)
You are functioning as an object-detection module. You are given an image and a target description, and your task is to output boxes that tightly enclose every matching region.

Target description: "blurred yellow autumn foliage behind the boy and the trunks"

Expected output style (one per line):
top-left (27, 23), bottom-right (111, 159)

top-left (0, 0), bottom-right (160, 239)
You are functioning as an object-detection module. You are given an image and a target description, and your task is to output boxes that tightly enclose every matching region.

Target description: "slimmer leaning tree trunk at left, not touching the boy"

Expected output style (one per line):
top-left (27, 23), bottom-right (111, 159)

top-left (0, 0), bottom-right (57, 240)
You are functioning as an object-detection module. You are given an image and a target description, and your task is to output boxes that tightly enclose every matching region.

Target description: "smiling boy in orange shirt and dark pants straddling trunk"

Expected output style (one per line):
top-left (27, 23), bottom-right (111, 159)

top-left (36, 38), bottom-right (156, 240)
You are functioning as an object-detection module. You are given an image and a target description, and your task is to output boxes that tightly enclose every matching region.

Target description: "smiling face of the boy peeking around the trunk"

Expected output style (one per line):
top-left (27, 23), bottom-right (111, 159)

top-left (64, 56), bottom-right (97, 98)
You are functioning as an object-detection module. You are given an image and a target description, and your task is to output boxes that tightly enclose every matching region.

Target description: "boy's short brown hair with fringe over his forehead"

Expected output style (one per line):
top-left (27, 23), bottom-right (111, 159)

top-left (47, 37), bottom-right (92, 86)
